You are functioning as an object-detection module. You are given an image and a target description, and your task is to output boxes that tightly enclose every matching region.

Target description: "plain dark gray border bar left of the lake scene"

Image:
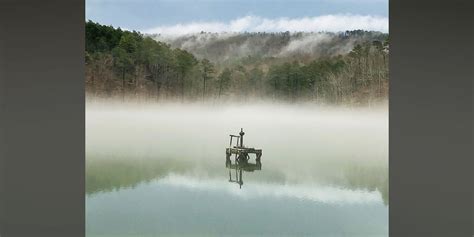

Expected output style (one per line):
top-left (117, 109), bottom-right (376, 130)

top-left (0, 0), bottom-right (85, 237)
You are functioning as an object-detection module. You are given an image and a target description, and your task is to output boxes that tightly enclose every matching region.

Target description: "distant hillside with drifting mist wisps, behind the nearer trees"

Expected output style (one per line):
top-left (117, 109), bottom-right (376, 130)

top-left (152, 32), bottom-right (374, 63)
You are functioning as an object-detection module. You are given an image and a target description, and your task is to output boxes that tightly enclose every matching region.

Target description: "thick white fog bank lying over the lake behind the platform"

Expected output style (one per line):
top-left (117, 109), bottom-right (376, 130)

top-left (86, 102), bottom-right (388, 187)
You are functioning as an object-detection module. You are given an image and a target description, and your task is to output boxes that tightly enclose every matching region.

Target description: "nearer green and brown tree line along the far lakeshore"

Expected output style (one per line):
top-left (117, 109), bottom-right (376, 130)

top-left (85, 21), bottom-right (389, 104)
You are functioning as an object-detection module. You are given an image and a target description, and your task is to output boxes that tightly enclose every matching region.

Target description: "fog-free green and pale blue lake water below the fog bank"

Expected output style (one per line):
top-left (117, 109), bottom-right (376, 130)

top-left (86, 158), bottom-right (388, 237)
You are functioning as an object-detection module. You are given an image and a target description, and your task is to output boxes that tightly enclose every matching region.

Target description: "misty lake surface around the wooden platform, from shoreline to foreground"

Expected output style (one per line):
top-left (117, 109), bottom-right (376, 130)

top-left (86, 103), bottom-right (388, 237)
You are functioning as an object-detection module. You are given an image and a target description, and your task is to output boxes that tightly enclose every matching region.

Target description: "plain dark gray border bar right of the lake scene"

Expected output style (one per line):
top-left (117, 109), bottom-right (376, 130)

top-left (389, 0), bottom-right (474, 237)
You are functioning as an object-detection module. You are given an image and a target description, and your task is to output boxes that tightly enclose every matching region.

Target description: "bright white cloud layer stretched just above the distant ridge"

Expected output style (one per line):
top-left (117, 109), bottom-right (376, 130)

top-left (143, 15), bottom-right (388, 36)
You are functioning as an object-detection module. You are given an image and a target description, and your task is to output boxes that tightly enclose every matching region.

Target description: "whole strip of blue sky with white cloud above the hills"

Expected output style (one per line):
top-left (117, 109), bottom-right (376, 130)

top-left (86, 0), bottom-right (388, 35)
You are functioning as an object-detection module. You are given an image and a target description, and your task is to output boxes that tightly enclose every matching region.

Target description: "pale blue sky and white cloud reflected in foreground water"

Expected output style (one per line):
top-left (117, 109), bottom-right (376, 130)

top-left (86, 171), bottom-right (388, 237)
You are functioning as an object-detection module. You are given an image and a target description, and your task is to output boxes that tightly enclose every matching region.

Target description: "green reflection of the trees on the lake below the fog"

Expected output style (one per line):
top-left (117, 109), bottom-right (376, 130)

top-left (86, 157), bottom-right (388, 205)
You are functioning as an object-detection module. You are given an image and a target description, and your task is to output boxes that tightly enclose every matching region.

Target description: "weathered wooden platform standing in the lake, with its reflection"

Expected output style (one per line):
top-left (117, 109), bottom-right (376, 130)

top-left (225, 128), bottom-right (262, 188)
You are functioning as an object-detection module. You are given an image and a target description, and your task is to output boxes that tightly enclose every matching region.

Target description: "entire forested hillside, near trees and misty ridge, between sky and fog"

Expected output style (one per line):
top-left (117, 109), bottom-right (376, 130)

top-left (86, 21), bottom-right (389, 104)
